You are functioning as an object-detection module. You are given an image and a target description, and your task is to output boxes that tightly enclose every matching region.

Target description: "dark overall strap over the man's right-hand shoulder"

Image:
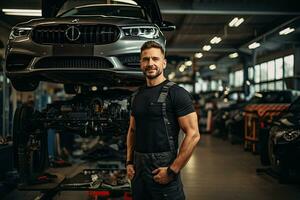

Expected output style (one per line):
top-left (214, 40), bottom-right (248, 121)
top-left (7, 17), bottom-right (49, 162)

top-left (157, 82), bottom-right (177, 155)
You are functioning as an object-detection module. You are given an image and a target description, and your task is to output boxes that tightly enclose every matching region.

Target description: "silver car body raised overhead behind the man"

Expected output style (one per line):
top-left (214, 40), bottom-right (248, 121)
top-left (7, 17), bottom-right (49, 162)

top-left (5, 1), bottom-right (169, 91)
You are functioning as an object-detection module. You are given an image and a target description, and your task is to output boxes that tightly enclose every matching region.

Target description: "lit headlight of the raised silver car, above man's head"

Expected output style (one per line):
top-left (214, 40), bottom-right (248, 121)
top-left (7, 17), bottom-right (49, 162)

top-left (122, 26), bottom-right (159, 39)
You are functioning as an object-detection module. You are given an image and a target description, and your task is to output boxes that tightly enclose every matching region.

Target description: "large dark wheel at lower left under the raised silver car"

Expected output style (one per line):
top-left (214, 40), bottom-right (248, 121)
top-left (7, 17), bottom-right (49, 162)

top-left (13, 105), bottom-right (48, 183)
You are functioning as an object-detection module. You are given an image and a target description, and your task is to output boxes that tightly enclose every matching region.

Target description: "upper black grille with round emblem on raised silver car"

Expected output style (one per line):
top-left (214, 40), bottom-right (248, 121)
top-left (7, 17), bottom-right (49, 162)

top-left (31, 24), bottom-right (120, 44)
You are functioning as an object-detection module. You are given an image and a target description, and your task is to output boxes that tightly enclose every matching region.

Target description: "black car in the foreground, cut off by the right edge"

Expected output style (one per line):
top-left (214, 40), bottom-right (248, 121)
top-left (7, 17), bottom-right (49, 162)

top-left (268, 98), bottom-right (300, 183)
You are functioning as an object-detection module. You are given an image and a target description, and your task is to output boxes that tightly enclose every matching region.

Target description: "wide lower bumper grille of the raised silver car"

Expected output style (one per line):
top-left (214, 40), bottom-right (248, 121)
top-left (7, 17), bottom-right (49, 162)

top-left (34, 56), bottom-right (113, 69)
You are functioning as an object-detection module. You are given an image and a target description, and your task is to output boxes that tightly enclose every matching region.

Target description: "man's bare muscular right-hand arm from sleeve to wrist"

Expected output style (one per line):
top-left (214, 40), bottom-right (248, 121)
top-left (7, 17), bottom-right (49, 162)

top-left (170, 112), bottom-right (200, 173)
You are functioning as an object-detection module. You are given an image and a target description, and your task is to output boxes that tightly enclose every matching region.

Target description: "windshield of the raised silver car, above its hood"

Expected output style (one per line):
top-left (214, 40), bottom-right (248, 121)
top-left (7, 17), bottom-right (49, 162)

top-left (59, 5), bottom-right (146, 19)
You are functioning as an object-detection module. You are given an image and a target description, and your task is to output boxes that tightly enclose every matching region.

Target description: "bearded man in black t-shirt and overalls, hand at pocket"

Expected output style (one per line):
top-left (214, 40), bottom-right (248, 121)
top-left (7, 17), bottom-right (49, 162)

top-left (126, 41), bottom-right (200, 200)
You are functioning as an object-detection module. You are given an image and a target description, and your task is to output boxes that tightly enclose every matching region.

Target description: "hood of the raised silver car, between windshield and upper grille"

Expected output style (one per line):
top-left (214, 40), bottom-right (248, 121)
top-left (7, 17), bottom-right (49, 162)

top-left (17, 16), bottom-right (152, 27)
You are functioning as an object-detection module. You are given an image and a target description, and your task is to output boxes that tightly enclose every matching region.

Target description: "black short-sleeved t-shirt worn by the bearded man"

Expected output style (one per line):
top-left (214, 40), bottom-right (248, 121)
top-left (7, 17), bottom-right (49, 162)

top-left (131, 80), bottom-right (195, 153)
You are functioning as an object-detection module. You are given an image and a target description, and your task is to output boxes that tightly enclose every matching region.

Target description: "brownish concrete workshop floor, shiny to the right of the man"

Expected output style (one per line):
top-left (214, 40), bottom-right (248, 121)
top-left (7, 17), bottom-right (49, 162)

top-left (0, 135), bottom-right (300, 200)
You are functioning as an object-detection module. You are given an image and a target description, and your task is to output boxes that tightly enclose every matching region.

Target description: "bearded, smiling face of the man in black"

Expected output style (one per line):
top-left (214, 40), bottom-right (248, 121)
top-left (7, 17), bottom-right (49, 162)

top-left (141, 48), bottom-right (166, 79)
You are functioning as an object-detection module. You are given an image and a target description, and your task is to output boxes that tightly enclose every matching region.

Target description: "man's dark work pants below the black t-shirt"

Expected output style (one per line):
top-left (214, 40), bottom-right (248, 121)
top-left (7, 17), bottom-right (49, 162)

top-left (131, 152), bottom-right (185, 200)
